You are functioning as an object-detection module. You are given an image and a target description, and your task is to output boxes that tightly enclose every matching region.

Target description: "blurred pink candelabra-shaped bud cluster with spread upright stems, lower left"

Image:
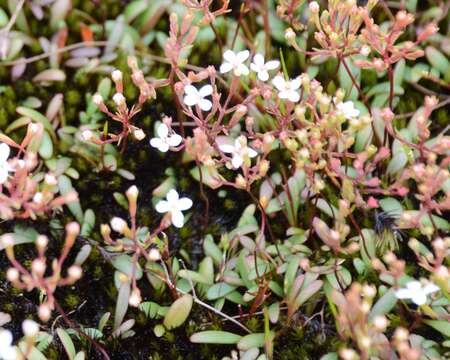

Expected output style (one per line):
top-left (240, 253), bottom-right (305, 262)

top-left (1, 222), bottom-right (83, 321)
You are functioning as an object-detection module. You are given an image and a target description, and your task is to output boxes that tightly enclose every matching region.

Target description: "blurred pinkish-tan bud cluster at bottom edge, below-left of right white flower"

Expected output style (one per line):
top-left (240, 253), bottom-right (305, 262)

top-left (333, 283), bottom-right (391, 360)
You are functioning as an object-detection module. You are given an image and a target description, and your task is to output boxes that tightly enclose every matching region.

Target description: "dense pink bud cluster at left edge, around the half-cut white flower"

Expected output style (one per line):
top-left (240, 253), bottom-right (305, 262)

top-left (0, 123), bottom-right (78, 220)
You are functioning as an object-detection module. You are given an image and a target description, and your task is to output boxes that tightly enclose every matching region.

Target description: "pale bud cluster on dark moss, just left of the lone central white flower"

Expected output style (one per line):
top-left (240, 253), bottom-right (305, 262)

top-left (100, 185), bottom-right (162, 307)
